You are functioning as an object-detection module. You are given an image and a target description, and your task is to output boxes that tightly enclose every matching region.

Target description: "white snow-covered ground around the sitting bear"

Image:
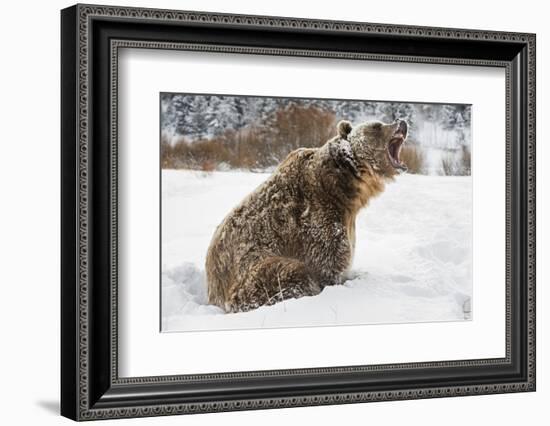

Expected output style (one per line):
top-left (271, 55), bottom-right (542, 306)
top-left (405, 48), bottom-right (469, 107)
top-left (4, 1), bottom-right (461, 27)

top-left (161, 170), bottom-right (472, 331)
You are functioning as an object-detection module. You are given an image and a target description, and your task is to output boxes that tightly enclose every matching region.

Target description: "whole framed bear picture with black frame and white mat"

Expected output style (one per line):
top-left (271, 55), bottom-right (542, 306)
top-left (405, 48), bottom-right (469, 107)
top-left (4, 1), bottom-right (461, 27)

top-left (61, 5), bottom-right (535, 420)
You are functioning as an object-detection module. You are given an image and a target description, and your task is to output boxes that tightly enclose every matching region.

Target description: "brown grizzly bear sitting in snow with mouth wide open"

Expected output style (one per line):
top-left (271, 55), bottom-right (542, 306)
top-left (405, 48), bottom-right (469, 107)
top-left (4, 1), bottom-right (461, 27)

top-left (206, 120), bottom-right (408, 312)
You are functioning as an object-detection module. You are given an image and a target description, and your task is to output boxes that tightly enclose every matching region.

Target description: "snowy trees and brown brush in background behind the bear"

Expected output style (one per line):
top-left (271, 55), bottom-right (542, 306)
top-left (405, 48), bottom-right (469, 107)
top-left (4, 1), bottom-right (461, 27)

top-left (161, 93), bottom-right (471, 174)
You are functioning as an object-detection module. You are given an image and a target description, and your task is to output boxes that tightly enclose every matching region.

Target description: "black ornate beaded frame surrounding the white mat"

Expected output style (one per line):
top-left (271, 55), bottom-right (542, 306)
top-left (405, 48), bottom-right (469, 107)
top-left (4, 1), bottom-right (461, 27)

top-left (61, 5), bottom-right (535, 420)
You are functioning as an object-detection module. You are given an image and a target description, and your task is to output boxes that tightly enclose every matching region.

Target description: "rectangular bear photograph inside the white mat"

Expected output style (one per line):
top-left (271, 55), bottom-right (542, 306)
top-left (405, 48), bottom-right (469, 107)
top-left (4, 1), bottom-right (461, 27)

top-left (159, 92), bottom-right (475, 332)
